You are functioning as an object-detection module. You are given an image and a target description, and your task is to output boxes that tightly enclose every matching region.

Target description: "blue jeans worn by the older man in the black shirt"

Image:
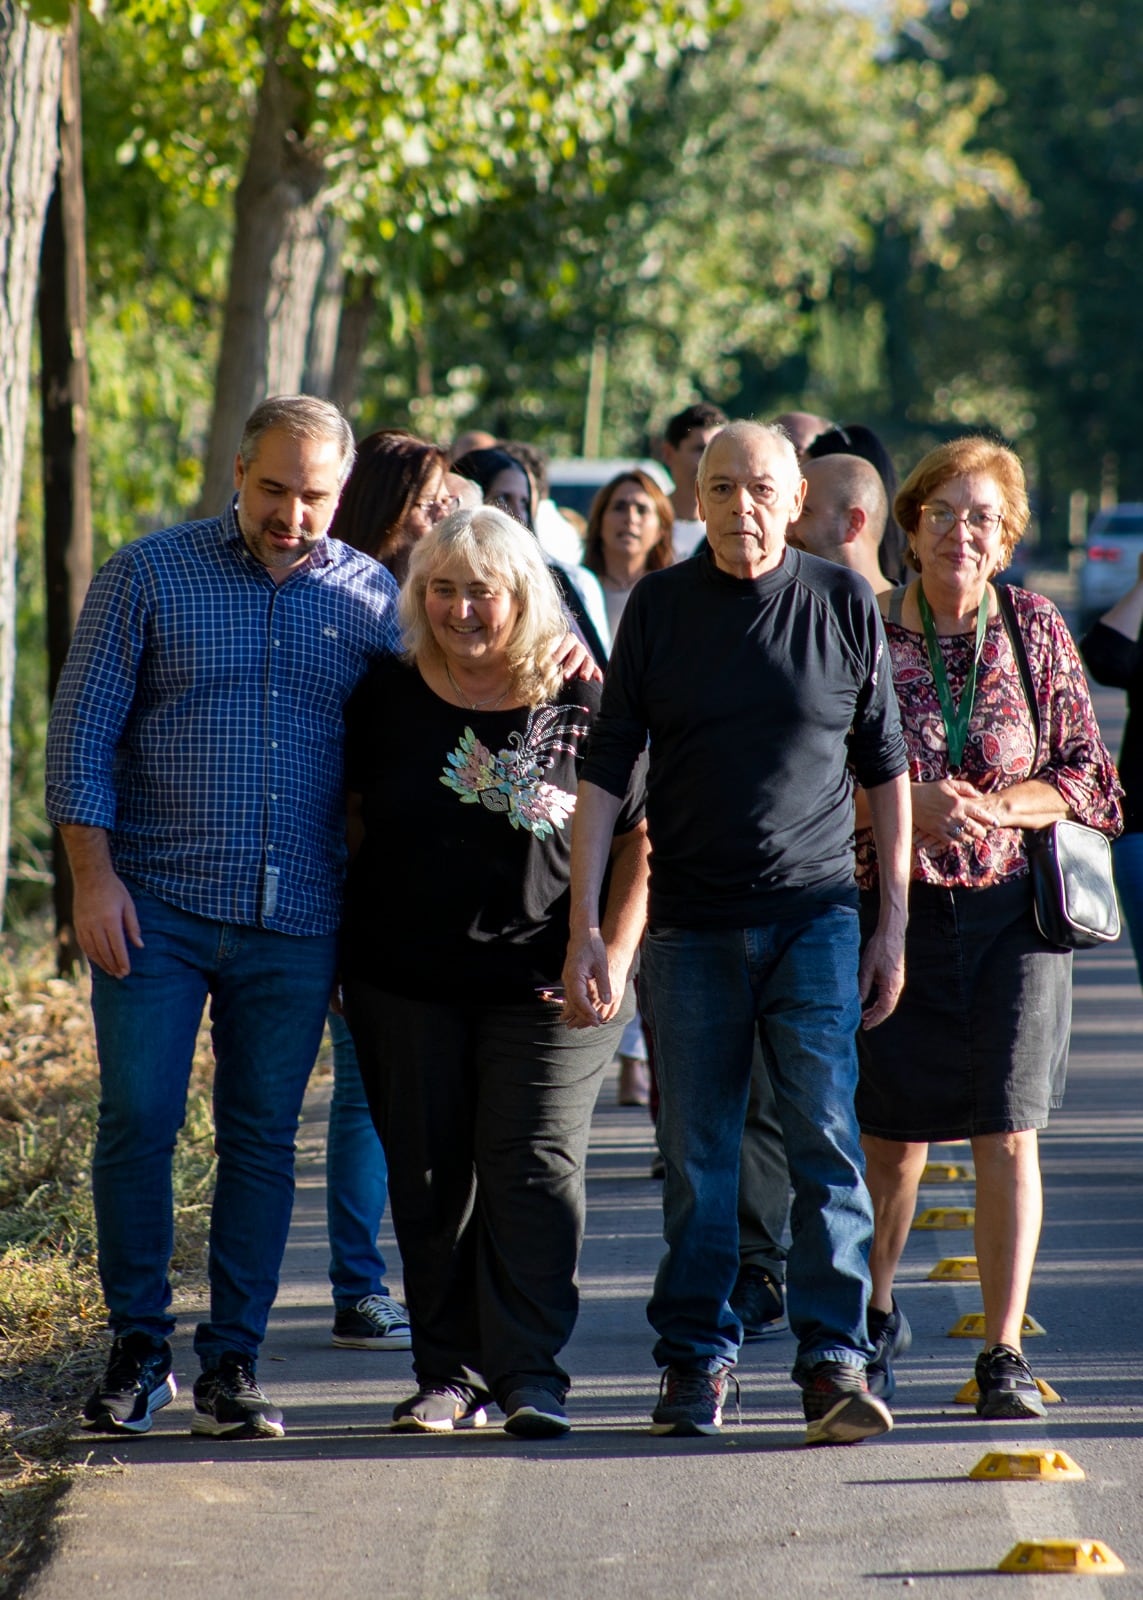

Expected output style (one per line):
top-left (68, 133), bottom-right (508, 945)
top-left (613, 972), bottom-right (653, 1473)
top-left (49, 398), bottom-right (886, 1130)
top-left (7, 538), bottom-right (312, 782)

top-left (640, 906), bottom-right (872, 1381)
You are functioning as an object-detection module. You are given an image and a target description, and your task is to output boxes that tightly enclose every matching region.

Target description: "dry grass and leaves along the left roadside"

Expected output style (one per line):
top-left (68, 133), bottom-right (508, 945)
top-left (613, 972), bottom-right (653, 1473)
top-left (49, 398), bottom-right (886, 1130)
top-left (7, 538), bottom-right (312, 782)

top-left (0, 947), bottom-right (215, 1597)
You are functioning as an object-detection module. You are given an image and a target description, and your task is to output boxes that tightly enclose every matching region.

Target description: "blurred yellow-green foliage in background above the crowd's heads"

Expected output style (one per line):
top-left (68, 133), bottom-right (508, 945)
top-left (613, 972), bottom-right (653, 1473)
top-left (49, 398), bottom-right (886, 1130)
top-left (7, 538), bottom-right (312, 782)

top-left (342, 0), bottom-right (1021, 451)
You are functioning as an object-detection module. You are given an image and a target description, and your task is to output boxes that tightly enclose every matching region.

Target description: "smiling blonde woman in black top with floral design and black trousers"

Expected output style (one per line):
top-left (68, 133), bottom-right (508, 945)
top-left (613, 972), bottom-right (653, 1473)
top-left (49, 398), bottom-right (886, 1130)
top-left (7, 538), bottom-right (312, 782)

top-left (341, 507), bottom-right (648, 1438)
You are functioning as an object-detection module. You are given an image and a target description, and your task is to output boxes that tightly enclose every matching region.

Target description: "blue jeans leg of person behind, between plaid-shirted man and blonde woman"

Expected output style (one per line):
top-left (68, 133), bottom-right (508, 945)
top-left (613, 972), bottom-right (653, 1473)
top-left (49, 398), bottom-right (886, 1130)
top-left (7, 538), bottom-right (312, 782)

top-left (325, 1011), bottom-right (389, 1310)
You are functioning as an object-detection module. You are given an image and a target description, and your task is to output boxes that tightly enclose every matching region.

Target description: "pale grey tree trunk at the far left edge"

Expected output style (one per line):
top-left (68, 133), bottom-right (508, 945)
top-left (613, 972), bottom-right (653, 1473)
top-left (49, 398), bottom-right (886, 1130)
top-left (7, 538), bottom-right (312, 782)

top-left (0, 0), bottom-right (62, 914)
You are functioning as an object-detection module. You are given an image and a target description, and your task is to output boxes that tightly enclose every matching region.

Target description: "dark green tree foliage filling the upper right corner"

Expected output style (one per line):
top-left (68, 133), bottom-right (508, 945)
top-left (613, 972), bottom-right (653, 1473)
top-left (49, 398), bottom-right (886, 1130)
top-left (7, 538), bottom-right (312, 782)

top-left (916, 0), bottom-right (1143, 538)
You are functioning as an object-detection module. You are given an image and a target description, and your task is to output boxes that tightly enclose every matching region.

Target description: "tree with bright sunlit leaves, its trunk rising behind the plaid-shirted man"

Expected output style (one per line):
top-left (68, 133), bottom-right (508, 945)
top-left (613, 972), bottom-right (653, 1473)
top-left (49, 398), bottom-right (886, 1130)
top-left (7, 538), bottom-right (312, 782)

top-left (95, 0), bottom-right (733, 510)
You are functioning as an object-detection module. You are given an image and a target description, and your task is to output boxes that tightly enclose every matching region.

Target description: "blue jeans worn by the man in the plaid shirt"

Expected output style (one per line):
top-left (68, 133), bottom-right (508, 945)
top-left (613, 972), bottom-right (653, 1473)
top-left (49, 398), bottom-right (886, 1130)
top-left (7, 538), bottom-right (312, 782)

top-left (91, 883), bottom-right (336, 1368)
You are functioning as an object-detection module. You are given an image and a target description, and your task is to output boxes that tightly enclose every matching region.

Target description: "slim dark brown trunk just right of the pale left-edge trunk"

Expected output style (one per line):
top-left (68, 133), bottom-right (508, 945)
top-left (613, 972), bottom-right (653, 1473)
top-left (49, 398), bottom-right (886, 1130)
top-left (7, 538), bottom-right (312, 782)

top-left (40, 11), bottom-right (91, 978)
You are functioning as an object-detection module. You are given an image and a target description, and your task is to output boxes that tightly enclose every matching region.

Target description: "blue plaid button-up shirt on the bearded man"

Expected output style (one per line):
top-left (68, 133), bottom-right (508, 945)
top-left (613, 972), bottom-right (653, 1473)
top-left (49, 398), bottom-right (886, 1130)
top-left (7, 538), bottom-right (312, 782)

top-left (46, 504), bottom-right (400, 934)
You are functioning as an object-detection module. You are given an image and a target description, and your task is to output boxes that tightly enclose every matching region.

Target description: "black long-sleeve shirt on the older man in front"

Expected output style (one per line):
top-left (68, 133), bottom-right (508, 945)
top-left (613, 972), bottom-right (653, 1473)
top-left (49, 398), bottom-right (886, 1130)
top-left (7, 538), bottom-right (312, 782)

top-left (581, 546), bottom-right (906, 928)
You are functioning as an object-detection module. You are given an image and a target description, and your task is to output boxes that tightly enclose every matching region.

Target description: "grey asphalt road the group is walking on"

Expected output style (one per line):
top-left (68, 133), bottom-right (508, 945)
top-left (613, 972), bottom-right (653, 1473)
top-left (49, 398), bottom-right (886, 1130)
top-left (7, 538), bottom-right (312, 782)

top-left (29, 672), bottom-right (1143, 1600)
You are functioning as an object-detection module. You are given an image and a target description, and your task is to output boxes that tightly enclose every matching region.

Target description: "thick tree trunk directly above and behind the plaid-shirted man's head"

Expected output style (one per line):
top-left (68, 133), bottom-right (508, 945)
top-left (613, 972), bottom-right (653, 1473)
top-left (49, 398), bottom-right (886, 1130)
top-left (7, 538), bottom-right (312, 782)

top-left (199, 51), bottom-right (325, 517)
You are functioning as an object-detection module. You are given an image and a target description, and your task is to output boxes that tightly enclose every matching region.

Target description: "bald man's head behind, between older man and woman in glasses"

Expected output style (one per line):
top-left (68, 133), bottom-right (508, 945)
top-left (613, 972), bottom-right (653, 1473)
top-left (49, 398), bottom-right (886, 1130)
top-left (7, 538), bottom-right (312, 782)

top-left (786, 456), bottom-right (893, 594)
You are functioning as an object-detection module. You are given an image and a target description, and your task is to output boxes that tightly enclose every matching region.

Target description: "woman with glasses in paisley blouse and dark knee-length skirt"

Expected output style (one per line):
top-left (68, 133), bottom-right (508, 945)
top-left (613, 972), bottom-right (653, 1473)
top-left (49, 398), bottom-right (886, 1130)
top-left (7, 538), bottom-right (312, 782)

top-left (856, 437), bottom-right (1121, 1418)
